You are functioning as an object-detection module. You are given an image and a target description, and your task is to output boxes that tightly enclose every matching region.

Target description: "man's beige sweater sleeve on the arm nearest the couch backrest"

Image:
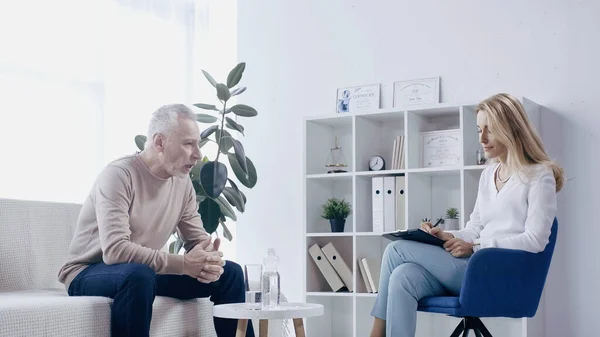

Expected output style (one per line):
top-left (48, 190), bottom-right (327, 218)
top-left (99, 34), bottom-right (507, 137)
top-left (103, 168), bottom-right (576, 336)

top-left (94, 165), bottom-right (183, 275)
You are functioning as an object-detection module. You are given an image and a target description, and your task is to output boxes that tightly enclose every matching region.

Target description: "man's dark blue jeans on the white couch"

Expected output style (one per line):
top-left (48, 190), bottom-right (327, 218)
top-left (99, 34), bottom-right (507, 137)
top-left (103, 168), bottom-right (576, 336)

top-left (68, 261), bottom-right (254, 337)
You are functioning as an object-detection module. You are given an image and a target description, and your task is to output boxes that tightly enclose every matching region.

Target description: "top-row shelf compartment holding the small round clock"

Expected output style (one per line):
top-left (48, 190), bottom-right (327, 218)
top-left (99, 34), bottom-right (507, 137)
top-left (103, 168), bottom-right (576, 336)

top-left (355, 111), bottom-right (407, 172)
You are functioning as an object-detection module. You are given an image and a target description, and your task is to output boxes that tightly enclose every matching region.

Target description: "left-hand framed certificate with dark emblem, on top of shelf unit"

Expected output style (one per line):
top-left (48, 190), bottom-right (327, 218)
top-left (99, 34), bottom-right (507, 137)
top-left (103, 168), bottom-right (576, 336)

top-left (336, 84), bottom-right (381, 113)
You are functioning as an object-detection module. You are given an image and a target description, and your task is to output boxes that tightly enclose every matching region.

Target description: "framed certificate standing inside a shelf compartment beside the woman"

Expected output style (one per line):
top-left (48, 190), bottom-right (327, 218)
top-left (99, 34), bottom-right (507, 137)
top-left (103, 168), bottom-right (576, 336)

top-left (421, 129), bottom-right (462, 167)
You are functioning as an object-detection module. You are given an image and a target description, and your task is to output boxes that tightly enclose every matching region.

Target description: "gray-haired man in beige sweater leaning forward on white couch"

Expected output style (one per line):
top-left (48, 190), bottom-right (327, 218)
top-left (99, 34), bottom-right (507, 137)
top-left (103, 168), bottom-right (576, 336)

top-left (58, 104), bottom-right (254, 337)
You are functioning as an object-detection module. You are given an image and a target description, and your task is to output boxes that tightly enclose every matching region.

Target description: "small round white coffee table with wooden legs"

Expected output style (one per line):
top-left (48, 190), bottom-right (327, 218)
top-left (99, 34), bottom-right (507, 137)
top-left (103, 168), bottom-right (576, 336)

top-left (213, 302), bottom-right (323, 337)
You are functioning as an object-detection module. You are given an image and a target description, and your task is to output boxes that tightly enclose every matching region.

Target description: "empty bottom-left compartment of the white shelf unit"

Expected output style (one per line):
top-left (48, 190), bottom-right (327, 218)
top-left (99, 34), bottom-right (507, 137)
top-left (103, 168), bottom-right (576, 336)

top-left (306, 295), bottom-right (354, 337)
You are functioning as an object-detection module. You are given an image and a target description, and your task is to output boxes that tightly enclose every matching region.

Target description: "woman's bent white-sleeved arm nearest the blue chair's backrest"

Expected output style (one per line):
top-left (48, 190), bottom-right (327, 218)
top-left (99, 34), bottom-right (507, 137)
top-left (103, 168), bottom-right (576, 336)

top-left (480, 169), bottom-right (557, 253)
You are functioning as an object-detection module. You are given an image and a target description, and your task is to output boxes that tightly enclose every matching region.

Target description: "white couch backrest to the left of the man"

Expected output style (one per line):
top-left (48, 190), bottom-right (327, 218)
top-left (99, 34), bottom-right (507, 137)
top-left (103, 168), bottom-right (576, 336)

top-left (0, 198), bottom-right (81, 291)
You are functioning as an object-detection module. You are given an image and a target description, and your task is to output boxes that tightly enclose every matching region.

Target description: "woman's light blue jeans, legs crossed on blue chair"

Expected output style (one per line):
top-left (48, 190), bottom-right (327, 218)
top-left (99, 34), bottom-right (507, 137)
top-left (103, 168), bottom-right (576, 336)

top-left (371, 240), bottom-right (469, 337)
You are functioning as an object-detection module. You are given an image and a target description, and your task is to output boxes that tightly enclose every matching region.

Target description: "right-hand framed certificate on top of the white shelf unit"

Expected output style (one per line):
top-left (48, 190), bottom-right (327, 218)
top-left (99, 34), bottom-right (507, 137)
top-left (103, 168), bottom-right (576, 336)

top-left (392, 77), bottom-right (440, 107)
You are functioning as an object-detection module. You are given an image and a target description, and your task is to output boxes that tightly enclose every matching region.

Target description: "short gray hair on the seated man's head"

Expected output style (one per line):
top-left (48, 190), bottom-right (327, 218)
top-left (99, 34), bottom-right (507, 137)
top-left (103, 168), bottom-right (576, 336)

top-left (145, 104), bottom-right (196, 147)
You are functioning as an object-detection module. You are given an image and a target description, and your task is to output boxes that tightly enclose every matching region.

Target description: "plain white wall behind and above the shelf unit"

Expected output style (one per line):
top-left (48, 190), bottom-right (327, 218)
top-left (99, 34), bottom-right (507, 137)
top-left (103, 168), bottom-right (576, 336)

top-left (237, 0), bottom-right (600, 336)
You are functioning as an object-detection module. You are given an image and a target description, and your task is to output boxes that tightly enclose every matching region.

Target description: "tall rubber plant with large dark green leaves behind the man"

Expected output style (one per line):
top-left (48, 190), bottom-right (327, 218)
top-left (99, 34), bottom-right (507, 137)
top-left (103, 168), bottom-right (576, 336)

top-left (135, 62), bottom-right (258, 254)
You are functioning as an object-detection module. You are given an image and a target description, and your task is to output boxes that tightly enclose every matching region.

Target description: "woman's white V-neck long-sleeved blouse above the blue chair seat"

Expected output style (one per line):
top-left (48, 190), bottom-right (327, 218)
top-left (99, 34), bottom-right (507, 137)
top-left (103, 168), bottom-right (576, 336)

top-left (448, 164), bottom-right (557, 253)
